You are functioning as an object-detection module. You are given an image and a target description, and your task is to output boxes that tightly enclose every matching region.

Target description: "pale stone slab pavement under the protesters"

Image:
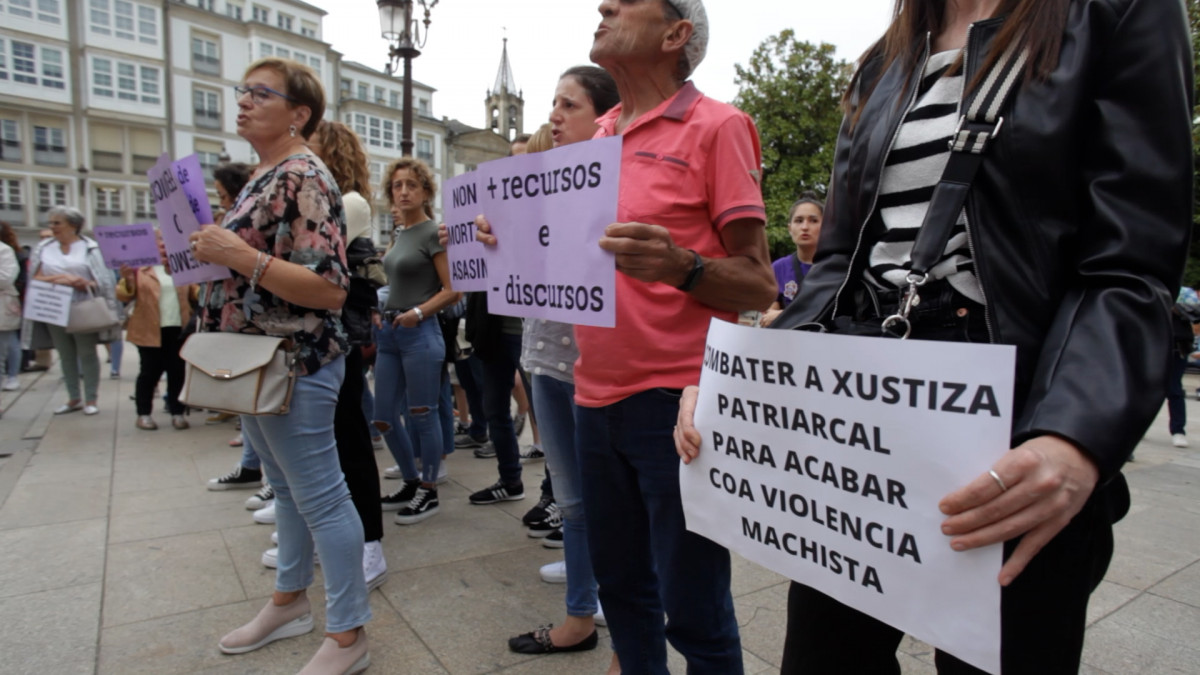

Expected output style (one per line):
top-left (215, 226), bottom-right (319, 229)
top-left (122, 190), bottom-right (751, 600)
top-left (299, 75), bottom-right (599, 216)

top-left (0, 353), bottom-right (1200, 675)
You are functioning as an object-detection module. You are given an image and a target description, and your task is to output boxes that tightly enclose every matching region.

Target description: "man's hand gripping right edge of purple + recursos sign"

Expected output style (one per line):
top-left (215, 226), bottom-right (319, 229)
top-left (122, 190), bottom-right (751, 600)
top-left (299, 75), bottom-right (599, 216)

top-left (600, 222), bottom-right (696, 286)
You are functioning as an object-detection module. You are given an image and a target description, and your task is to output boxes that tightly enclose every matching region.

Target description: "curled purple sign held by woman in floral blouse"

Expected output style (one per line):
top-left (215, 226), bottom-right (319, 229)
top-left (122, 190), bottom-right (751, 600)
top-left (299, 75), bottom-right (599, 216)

top-left (146, 154), bottom-right (229, 285)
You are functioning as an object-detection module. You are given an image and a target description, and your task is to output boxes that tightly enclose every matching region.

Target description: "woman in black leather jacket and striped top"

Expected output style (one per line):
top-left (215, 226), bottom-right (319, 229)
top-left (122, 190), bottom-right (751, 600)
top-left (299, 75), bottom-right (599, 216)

top-left (676, 0), bottom-right (1193, 673)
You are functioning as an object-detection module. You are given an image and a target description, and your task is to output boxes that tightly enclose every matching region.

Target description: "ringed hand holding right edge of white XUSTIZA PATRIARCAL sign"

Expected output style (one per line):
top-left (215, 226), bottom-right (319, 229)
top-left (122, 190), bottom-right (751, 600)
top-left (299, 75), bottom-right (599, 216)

top-left (938, 436), bottom-right (1099, 586)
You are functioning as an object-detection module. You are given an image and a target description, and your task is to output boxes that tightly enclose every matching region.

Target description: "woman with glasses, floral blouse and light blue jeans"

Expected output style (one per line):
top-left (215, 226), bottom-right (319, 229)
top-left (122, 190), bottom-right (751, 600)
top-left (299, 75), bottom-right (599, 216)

top-left (191, 59), bottom-right (371, 675)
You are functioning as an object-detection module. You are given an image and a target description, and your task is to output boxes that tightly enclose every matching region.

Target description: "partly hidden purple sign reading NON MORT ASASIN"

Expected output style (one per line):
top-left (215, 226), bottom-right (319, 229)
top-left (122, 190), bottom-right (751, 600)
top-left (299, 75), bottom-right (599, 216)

top-left (442, 172), bottom-right (492, 291)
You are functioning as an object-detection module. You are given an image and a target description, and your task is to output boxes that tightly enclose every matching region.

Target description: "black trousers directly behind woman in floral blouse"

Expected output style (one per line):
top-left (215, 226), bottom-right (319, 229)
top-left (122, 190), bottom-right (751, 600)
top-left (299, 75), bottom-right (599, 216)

top-left (334, 347), bottom-right (383, 542)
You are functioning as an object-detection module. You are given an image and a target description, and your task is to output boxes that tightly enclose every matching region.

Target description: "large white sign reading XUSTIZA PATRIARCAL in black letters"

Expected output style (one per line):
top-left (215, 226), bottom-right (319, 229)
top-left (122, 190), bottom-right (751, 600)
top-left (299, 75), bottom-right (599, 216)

top-left (679, 319), bottom-right (1015, 673)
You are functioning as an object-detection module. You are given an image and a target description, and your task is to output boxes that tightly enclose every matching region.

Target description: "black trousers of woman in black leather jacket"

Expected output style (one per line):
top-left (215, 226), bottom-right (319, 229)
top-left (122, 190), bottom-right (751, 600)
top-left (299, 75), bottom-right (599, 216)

top-left (780, 487), bottom-right (1128, 675)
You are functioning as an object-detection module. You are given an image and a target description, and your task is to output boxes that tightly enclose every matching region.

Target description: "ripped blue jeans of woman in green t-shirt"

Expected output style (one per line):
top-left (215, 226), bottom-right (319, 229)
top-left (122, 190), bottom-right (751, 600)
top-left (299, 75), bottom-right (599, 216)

top-left (374, 321), bottom-right (454, 483)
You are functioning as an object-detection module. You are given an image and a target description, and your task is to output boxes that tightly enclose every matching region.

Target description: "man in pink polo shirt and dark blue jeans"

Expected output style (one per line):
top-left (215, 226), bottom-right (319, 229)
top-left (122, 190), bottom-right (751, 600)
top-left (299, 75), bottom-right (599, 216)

top-left (575, 0), bottom-right (775, 674)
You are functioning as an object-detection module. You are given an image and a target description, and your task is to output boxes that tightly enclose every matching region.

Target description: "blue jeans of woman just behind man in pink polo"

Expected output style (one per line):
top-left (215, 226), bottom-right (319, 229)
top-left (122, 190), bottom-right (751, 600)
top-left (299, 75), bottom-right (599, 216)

top-left (532, 375), bottom-right (599, 616)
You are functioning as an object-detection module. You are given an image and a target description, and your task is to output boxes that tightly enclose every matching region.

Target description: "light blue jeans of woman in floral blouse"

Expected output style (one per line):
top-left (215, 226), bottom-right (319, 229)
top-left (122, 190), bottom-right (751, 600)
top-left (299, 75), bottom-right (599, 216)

top-left (241, 357), bottom-right (371, 633)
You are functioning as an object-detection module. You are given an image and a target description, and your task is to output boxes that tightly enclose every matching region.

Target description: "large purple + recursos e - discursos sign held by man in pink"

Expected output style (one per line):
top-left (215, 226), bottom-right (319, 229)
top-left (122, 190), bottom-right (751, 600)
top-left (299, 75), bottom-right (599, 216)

top-left (476, 136), bottom-right (622, 328)
